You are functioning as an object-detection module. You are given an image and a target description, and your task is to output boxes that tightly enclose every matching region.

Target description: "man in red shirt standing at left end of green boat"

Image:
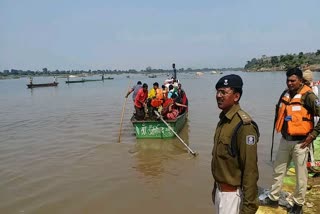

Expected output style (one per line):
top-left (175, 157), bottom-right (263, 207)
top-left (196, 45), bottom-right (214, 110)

top-left (134, 83), bottom-right (148, 120)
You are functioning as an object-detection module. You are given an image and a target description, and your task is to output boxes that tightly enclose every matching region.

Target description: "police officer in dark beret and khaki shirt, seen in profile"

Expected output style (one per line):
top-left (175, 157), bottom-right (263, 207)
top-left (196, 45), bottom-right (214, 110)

top-left (211, 74), bottom-right (259, 214)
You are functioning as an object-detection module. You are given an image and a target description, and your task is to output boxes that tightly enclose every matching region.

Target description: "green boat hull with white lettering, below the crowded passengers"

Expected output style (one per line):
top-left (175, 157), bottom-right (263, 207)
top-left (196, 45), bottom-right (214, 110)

top-left (131, 112), bottom-right (188, 139)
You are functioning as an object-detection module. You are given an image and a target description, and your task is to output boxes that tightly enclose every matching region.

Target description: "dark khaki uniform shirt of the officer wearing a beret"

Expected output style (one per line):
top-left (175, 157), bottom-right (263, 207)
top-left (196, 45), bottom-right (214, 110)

top-left (211, 104), bottom-right (259, 213)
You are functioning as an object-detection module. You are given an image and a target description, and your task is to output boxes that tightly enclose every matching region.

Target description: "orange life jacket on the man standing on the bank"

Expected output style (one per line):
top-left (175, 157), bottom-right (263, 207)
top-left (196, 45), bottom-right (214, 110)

top-left (275, 85), bottom-right (313, 136)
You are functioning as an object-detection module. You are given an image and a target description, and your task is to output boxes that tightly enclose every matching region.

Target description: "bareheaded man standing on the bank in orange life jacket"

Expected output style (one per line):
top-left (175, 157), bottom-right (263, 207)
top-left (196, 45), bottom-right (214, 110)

top-left (260, 68), bottom-right (320, 214)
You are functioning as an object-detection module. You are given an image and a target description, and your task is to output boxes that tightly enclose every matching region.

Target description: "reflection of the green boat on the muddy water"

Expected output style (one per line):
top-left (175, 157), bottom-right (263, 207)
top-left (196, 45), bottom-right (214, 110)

top-left (133, 121), bottom-right (190, 178)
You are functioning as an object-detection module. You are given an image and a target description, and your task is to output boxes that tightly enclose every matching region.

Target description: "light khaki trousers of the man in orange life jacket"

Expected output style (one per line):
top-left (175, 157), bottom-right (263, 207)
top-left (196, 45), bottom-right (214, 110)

top-left (269, 137), bottom-right (309, 205)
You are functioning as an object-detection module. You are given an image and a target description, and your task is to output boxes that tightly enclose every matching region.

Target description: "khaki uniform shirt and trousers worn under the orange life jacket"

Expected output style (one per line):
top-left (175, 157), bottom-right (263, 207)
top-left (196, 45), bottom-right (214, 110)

top-left (268, 87), bottom-right (320, 206)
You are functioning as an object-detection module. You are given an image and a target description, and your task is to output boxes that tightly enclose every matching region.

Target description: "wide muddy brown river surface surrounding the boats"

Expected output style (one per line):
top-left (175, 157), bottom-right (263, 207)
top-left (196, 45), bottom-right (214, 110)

top-left (0, 71), bottom-right (320, 214)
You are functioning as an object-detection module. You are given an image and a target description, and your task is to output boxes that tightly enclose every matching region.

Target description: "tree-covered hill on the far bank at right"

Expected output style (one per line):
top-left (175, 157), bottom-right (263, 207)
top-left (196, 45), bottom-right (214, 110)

top-left (244, 50), bottom-right (320, 71)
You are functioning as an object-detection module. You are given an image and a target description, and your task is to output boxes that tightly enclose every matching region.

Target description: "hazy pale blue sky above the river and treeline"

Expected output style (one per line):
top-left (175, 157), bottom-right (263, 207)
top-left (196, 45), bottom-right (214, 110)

top-left (0, 0), bottom-right (320, 71)
